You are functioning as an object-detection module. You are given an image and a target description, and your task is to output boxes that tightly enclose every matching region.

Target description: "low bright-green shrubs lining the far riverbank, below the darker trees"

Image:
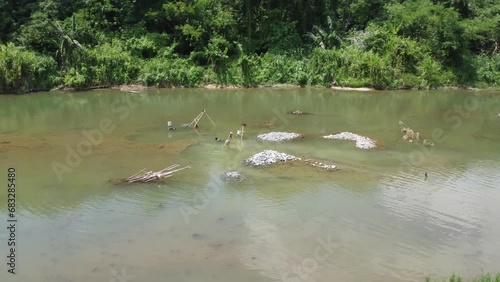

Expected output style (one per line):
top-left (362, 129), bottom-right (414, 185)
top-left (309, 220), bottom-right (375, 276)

top-left (0, 41), bottom-right (500, 93)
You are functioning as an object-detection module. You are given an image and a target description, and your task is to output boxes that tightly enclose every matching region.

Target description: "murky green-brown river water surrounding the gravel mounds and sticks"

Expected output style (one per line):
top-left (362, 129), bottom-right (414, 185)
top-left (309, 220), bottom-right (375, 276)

top-left (0, 89), bottom-right (500, 282)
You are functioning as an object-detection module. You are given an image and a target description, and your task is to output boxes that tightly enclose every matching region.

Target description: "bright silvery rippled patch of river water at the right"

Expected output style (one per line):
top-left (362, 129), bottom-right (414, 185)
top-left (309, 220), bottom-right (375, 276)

top-left (380, 163), bottom-right (481, 229)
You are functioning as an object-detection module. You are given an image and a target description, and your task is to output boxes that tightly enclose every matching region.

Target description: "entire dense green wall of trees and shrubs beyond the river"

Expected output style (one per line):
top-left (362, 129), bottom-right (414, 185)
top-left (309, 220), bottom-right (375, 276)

top-left (0, 0), bottom-right (500, 93)
